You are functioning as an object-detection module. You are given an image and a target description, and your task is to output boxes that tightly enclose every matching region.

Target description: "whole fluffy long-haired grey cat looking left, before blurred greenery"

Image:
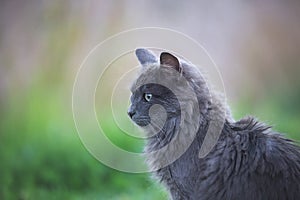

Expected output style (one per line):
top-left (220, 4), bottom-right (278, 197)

top-left (128, 49), bottom-right (300, 200)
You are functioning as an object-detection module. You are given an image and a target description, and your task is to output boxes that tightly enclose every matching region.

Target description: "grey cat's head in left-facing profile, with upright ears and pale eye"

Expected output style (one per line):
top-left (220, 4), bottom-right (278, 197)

top-left (128, 49), bottom-right (208, 127)
